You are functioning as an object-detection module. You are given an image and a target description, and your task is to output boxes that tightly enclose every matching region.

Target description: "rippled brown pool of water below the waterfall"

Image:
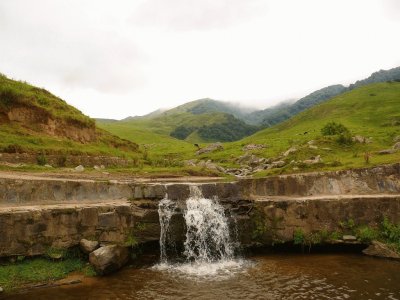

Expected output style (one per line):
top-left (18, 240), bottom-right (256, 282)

top-left (6, 254), bottom-right (400, 300)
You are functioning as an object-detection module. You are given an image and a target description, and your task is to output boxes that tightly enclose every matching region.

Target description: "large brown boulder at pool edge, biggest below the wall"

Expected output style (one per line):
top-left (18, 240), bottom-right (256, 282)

top-left (89, 245), bottom-right (129, 275)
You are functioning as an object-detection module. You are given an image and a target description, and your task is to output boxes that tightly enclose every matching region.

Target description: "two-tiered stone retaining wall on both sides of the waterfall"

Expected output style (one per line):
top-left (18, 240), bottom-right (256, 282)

top-left (0, 164), bottom-right (400, 257)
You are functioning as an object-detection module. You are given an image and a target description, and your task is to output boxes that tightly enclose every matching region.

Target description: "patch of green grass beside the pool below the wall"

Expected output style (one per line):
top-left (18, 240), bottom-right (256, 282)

top-left (0, 257), bottom-right (95, 292)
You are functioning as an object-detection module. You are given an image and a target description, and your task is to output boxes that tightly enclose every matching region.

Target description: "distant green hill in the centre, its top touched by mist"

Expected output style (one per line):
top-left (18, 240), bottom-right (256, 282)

top-left (99, 99), bottom-right (258, 143)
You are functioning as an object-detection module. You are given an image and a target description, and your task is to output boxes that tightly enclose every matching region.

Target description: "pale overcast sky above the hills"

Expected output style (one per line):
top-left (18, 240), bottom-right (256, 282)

top-left (0, 0), bottom-right (400, 119)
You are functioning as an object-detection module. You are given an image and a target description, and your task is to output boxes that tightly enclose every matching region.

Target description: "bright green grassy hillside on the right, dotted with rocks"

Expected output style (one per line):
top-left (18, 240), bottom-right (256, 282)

top-left (203, 82), bottom-right (400, 176)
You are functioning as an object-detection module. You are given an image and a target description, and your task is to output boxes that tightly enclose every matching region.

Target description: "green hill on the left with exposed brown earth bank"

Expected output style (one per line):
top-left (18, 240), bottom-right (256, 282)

top-left (0, 75), bottom-right (140, 161)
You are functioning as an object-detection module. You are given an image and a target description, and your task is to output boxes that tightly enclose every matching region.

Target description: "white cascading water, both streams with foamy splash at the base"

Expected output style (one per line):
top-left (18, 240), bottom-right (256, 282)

top-left (156, 186), bottom-right (243, 279)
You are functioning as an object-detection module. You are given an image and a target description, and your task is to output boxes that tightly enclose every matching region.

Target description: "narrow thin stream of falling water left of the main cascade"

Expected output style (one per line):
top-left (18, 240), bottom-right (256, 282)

top-left (158, 195), bottom-right (176, 263)
